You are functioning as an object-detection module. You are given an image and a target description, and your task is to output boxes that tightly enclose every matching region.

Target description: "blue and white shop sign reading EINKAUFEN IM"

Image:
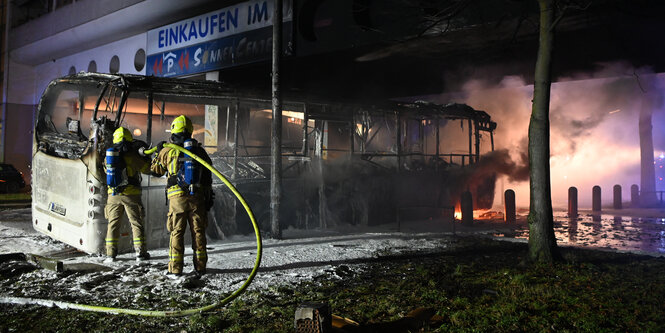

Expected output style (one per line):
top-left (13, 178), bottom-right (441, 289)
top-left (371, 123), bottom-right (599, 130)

top-left (146, 0), bottom-right (293, 76)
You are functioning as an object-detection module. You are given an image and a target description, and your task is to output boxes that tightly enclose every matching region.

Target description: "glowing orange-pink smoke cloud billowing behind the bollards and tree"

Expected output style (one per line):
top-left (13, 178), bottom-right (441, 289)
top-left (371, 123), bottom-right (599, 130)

top-left (428, 63), bottom-right (665, 209)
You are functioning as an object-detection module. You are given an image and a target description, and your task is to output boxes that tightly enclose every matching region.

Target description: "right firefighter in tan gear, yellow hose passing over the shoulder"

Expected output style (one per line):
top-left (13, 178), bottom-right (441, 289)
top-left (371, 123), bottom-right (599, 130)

top-left (150, 116), bottom-right (212, 275)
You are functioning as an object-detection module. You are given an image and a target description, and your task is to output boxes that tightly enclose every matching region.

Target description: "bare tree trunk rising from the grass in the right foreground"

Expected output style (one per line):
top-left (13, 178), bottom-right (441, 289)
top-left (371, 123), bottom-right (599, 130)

top-left (528, 0), bottom-right (558, 262)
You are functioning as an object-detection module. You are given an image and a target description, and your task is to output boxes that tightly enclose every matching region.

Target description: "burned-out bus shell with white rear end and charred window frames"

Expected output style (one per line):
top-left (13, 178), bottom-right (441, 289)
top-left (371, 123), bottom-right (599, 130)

top-left (32, 73), bottom-right (496, 253)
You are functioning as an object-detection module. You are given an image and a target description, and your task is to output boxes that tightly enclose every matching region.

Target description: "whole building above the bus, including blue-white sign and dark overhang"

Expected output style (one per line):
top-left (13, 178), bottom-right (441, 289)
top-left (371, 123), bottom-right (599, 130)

top-left (6, 0), bottom-right (665, 187)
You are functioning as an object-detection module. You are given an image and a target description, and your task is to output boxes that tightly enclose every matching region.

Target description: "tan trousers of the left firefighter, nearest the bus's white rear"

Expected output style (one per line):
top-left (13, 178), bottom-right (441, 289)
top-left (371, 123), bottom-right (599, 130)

top-left (104, 195), bottom-right (147, 257)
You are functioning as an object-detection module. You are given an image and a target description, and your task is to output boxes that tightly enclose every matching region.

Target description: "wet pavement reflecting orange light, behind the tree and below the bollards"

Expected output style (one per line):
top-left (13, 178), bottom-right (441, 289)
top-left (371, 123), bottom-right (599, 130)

top-left (494, 209), bottom-right (665, 255)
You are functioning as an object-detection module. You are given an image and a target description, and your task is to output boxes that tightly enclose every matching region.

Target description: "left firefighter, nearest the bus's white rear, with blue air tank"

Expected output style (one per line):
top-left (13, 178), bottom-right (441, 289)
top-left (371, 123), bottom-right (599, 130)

top-left (104, 127), bottom-right (150, 261)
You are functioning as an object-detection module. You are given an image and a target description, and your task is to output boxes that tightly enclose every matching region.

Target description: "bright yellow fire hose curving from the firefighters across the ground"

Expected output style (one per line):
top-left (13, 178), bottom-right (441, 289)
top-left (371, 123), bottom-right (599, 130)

top-left (0, 143), bottom-right (262, 317)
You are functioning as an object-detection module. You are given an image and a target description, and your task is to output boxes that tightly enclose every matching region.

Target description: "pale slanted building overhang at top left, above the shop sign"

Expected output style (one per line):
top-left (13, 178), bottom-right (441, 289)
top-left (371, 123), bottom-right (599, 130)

top-left (9, 0), bottom-right (224, 66)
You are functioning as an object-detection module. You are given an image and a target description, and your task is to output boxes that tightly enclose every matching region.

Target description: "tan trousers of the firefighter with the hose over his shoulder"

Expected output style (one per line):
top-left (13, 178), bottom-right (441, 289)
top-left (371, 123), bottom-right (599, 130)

top-left (166, 194), bottom-right (208, 274)
